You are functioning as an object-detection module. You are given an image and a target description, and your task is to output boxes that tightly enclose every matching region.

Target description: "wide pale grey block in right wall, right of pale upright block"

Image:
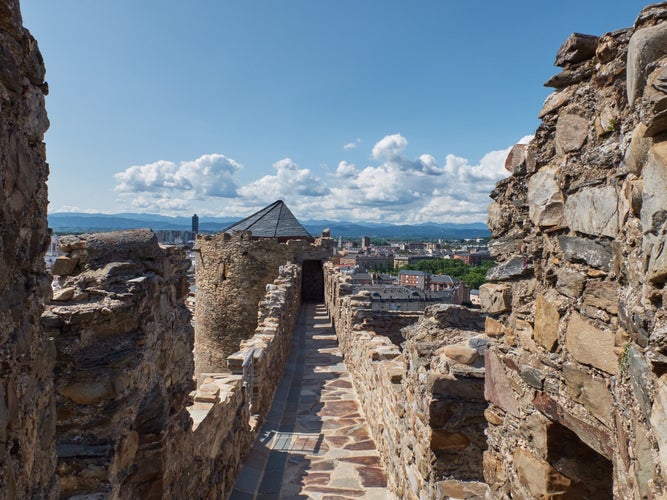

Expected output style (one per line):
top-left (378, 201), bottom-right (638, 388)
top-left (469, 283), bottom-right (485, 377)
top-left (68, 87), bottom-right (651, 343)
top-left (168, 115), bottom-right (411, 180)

top-left (564, 186), bottom-right (629, 238)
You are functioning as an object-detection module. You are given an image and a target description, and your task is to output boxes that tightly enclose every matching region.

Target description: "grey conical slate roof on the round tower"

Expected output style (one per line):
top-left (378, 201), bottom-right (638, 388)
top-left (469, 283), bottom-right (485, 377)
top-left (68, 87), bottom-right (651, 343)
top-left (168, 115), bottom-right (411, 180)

top-left (223, 200), bottom-right (312, 238)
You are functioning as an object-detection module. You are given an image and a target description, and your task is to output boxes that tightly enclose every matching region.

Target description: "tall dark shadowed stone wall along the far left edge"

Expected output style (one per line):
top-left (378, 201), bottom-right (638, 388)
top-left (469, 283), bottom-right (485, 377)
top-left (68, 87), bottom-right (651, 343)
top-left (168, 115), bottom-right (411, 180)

top-left (0, 0), bottom-right (58, 498)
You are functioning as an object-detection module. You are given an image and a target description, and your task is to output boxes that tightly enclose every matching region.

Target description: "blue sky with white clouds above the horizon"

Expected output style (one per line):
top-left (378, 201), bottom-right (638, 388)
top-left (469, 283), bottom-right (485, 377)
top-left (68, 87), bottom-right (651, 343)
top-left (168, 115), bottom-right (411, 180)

top-left (21, 0), bottom-right (647, 224)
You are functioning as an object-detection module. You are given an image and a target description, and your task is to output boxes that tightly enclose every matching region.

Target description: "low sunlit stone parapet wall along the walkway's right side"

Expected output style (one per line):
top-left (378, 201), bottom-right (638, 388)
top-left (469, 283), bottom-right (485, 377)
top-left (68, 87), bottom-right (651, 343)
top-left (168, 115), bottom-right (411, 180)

top-left (325, 266), bottom-right (488, 499)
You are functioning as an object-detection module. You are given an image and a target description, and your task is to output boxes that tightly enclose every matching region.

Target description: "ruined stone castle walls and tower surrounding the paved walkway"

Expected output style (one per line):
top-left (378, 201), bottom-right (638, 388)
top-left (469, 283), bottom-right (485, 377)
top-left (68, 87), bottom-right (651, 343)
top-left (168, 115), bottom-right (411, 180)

top-left (0, 0), bottom-right (667, 499)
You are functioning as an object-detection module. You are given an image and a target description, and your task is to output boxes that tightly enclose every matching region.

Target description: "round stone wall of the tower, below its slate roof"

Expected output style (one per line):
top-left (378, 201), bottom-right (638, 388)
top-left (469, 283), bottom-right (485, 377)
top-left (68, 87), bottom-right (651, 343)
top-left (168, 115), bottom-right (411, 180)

top-left (195, 231), bottom-right (333, 373)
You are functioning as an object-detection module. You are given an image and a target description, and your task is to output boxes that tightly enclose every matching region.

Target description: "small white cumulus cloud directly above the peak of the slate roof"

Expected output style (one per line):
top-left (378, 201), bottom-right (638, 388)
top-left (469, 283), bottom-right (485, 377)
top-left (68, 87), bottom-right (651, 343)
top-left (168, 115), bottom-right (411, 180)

top-left (238, 158), bottom-right (328, 203)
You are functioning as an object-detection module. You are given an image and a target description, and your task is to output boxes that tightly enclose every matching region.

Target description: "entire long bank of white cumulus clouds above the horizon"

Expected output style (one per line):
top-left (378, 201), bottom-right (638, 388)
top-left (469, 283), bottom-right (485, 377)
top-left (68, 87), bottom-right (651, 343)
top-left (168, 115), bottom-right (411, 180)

top-left (115, 133), bottom-right (520, 223)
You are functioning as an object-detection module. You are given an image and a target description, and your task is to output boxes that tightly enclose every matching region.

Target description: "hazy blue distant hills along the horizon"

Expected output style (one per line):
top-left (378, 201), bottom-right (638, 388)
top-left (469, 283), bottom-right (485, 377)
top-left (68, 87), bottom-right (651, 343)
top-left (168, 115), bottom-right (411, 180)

top-left (49, 212), bottom-right (490, 240)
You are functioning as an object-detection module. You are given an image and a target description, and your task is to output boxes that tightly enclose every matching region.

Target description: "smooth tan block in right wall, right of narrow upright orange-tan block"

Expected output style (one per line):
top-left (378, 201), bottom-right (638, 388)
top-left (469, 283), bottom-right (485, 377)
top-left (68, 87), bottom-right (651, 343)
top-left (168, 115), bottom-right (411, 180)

top-left (565, 312), bottom-right (618, 374)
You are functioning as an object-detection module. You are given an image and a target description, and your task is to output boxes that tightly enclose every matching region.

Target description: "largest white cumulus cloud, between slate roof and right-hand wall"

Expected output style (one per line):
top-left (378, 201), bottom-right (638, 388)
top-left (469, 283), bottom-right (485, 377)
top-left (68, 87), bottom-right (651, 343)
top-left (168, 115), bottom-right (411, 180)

top-left (310, 134), bottom-right (510, 223)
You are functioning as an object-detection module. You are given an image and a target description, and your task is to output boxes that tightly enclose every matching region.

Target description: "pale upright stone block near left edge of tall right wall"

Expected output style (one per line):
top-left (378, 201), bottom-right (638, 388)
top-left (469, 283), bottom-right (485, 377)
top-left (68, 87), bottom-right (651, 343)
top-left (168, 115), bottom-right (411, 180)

top-left (528, 167), bottom-right (565, 227)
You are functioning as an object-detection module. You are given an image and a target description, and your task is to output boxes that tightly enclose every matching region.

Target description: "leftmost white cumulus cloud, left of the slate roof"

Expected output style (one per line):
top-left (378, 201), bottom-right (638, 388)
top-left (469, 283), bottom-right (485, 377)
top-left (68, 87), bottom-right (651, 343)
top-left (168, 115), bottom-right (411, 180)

top-left (114, 154), bottom-right (241, 198)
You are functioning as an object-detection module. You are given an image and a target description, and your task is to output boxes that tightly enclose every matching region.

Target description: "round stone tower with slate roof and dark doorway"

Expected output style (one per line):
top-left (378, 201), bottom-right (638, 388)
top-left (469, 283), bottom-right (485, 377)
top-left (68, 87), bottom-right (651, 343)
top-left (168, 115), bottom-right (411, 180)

top-left (195, 200), bottom-right (333, 373)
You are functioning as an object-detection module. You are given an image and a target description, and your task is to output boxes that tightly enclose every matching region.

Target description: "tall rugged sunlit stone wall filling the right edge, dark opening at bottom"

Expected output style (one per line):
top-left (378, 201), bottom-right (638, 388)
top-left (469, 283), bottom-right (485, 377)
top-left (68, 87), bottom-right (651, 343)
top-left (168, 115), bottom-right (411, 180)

top-left (480, 3), bottom-right (667, 498)
